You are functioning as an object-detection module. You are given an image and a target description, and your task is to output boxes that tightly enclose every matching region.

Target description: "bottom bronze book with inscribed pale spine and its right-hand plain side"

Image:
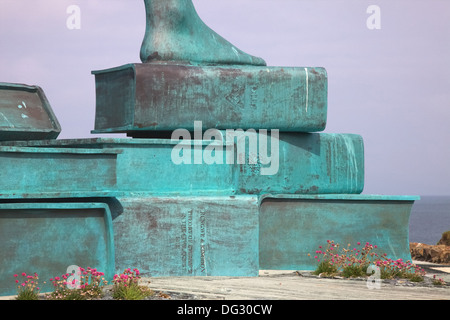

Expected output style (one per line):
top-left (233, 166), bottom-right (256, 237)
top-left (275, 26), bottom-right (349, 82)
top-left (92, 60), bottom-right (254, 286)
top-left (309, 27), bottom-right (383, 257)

top-left (114, 195), bottom-right (419, 277)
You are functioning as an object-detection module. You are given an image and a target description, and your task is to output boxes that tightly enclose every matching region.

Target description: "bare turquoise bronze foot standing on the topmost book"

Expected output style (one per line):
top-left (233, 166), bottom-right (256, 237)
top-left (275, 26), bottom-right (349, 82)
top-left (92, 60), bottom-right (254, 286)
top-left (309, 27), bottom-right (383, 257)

top-left (140, 0), bottom-right (266, 66)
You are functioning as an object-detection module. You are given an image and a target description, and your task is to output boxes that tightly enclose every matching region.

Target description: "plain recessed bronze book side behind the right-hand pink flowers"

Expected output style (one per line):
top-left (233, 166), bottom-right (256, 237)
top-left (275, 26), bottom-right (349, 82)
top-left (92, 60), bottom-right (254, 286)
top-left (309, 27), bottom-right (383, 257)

top-left (259, 195), bottom-right (419, 270)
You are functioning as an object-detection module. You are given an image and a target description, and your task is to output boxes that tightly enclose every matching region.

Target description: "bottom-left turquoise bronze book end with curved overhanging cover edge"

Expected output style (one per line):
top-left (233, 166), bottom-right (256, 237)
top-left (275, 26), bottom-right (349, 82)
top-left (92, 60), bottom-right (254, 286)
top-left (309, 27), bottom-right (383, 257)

top-left (0, 199), bottom-right (116, 295)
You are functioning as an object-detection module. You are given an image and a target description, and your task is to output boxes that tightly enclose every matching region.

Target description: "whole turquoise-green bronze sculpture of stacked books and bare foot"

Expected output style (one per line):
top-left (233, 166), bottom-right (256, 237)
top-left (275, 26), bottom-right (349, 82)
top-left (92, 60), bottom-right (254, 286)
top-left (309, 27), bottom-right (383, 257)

top-left (0, 0), bottom-right (418, 295)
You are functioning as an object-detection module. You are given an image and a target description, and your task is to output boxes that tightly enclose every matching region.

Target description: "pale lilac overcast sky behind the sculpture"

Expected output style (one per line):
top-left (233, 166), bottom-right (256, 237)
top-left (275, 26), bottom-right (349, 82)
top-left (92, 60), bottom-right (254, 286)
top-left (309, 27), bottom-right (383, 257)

top-left (0, 0), bottom-right (450, 195)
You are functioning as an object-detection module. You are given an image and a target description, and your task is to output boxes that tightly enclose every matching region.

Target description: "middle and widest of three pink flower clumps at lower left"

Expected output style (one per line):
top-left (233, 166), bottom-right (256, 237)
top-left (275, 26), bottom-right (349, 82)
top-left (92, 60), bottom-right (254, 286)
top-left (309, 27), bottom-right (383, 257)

top-left (47, 267), bottom-right (107, 300)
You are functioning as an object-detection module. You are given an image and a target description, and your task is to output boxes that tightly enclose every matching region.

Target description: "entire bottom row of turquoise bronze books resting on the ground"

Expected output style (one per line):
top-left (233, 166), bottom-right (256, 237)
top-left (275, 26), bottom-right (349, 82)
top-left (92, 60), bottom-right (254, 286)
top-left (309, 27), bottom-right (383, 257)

top-left (0, 193), bottom-right (418, 295)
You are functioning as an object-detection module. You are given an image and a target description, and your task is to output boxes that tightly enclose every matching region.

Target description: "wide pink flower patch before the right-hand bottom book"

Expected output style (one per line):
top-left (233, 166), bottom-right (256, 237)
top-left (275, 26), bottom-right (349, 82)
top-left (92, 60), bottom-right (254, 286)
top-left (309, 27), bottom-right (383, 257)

top-left (308, 240), bottom-right (425, 281)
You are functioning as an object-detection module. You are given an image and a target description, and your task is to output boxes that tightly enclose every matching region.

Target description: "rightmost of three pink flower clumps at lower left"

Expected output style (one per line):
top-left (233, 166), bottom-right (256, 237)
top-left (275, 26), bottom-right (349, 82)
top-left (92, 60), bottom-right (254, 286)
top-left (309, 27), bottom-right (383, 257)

top-left (112, 268), bottom-right (153, 300)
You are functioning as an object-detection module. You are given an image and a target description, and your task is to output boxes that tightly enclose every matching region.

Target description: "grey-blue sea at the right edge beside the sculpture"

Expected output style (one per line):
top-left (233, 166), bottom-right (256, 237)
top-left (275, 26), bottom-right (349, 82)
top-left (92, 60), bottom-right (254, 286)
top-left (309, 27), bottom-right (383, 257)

top-left (409, 196), bottom-right (450, 245)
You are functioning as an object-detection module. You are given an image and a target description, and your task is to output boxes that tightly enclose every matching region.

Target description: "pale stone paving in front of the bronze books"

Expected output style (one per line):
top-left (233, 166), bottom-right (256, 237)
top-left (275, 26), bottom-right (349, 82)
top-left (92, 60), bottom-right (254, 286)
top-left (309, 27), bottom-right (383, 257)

top-left (150, 264), bottom-right (450, 300)
